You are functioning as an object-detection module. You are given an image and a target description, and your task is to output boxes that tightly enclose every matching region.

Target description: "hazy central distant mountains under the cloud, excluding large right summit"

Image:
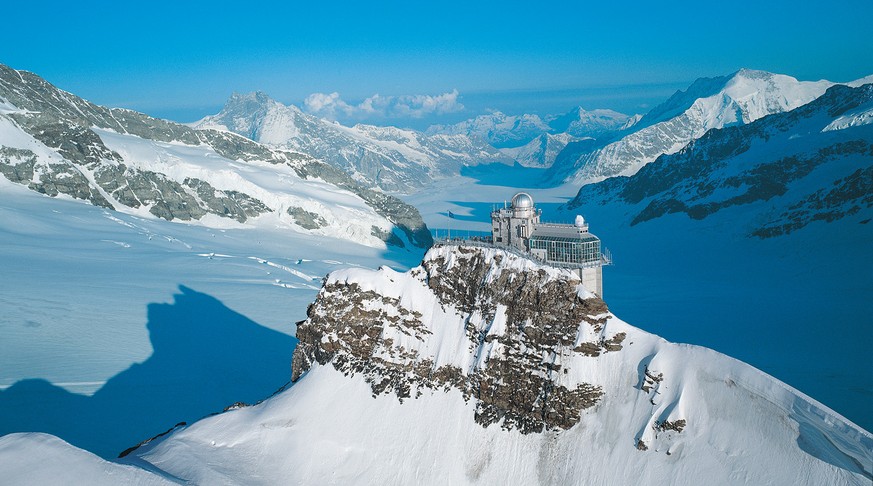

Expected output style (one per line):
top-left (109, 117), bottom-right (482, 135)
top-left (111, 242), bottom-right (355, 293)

top-left (191, 96), bottom-right (639, 185)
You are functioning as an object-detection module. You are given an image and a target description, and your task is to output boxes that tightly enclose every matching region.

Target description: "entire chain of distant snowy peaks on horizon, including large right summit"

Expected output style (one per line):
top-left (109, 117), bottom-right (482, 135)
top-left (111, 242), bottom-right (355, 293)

top-left (184, 69), bottom-right (863, 193)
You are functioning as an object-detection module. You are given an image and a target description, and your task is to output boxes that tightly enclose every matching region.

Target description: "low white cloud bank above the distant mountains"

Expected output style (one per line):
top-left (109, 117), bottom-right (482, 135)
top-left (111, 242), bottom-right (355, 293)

top-left (303, 89), bottom-right (464, 120)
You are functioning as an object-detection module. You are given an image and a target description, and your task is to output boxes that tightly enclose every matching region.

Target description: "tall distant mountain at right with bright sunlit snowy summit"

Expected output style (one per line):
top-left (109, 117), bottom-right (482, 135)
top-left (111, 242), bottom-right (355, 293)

top-left (548, 69), bottom-right (834, 184)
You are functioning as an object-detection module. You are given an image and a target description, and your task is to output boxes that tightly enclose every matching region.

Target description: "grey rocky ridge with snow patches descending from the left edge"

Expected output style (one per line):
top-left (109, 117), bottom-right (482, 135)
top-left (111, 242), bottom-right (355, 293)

top-left (0, 65), bottom-right (432, 247)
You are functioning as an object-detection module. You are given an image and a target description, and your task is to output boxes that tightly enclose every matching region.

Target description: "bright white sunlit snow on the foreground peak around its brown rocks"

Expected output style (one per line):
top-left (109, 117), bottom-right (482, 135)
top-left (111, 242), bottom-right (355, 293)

top-left (135, 247), bottom-right (873, 485)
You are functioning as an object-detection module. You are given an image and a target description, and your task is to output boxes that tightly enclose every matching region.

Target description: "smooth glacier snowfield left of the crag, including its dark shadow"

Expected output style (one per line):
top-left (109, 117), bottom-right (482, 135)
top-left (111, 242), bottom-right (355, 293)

top-left (0, 178), bottom-right (421, 457)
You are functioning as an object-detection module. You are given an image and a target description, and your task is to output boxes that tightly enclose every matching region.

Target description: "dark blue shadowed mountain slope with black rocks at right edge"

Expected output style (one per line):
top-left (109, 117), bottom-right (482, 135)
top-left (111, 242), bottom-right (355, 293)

top-left (567, 84), bottom-right (873, 238)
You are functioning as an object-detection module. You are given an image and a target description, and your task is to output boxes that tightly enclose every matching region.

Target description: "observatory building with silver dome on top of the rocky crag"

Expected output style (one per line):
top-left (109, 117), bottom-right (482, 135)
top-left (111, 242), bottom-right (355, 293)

top-left (491, 192), bottom-right (610, 297)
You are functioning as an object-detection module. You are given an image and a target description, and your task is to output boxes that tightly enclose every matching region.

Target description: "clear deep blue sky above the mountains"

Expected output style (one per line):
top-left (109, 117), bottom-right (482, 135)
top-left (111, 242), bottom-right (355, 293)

top-left (0, 0), bottom-right (873, 126)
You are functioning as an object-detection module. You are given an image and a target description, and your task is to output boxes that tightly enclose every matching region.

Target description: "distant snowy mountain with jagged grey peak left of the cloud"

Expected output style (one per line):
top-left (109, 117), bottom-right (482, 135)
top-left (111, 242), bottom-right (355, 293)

top-left (192, 92), bottom-right (512, 192)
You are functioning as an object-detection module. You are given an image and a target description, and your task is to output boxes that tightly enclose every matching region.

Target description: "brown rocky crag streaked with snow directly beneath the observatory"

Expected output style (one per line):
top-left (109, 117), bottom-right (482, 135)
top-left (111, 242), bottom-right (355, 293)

top-left (292, 245), bottom-right (625, 433)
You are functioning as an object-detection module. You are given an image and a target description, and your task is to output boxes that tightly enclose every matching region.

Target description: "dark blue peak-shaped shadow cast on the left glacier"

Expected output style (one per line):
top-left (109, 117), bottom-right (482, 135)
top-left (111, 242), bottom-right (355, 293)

top-left (0, 286), bottom-right (297, 458)
